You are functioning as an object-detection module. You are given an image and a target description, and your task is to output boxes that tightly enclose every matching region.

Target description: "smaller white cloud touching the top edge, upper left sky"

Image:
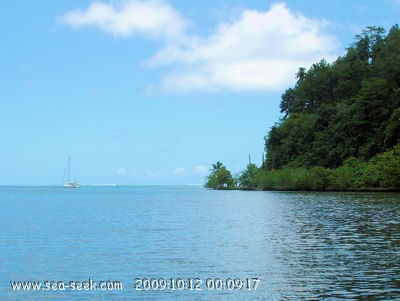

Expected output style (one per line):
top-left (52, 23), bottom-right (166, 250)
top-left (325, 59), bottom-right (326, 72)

top-left (59, 0), bottom-right (188, 40)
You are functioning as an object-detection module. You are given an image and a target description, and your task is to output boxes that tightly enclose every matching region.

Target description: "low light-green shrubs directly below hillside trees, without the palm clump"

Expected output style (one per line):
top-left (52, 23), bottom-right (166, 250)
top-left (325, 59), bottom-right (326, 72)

top-left (258, 144), bottom-right (400, 190)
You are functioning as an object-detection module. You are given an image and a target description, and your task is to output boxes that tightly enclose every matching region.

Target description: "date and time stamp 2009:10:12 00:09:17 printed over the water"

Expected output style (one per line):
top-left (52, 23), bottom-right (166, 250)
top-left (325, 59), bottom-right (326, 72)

top-left (134, 277), bottom-right (260, 291)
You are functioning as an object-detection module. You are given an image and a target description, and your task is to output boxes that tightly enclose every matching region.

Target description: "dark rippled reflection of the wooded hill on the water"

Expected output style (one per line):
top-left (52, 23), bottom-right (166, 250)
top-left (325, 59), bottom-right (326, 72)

top-left (273, 193), bottom-right (400, 300)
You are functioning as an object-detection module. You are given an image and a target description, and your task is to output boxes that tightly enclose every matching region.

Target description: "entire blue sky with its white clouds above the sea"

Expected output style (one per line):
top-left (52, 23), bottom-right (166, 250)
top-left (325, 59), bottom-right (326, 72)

top-left (0, 0), bottom-right (400, 185)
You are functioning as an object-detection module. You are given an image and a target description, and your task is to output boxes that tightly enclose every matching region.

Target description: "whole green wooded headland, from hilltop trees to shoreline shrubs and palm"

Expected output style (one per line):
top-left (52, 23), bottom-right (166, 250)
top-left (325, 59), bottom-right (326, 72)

top-left (206, 25), bottom-right (400, 190)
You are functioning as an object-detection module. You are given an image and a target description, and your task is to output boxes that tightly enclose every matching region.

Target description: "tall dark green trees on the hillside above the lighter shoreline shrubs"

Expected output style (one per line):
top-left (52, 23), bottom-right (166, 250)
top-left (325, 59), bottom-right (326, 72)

top-left (265, 25), bottom-right (400, 171)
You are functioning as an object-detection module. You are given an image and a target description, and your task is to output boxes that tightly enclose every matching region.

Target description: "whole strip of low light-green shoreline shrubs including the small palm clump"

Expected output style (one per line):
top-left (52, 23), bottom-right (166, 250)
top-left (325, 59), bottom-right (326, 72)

top-left (205, 143), bottom-right (400, 191)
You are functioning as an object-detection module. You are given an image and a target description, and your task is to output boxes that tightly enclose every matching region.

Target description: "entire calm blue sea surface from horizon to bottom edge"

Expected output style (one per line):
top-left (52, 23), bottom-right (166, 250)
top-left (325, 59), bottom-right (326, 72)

top-left (0, 186), bottom-right (400, 300)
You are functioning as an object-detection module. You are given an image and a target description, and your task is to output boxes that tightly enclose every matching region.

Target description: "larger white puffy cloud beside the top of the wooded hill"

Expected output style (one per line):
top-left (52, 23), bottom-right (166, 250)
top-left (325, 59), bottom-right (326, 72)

top-left (149, 4), bottom-right (338, 92)
